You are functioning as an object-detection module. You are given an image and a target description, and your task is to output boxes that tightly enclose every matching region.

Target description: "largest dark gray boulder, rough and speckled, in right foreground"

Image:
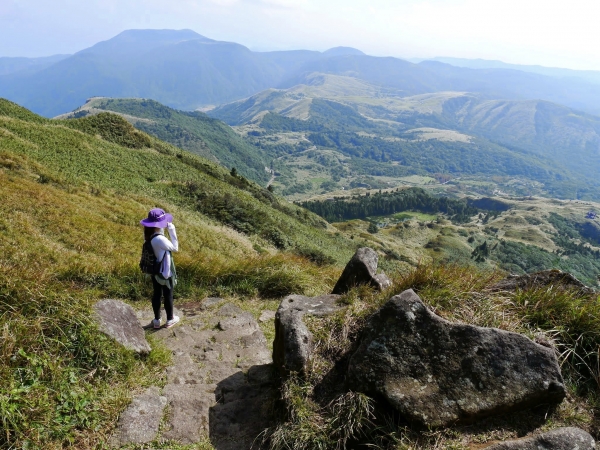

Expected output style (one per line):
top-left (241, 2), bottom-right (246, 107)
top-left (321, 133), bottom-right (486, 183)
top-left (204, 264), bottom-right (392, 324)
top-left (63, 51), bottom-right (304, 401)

top-left (348, 290), bottom-right (565, 426)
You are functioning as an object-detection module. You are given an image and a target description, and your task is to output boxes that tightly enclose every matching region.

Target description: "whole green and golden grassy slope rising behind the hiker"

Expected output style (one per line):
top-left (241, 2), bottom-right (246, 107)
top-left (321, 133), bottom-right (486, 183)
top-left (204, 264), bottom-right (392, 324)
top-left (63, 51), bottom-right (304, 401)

top-left (0, 101), bottom-right (355, 448)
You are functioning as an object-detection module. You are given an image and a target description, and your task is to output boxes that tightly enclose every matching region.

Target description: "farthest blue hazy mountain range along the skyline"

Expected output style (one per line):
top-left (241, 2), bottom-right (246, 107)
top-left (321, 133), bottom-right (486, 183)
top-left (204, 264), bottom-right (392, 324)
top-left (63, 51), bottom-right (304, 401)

top-left (0, 30), bottom-right (600, 116)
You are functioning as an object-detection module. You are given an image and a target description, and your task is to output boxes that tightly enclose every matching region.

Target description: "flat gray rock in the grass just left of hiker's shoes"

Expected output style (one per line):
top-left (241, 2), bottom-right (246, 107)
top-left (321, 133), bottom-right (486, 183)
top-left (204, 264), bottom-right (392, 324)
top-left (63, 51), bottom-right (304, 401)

top-left (94, 300), bottom-right (151, 355)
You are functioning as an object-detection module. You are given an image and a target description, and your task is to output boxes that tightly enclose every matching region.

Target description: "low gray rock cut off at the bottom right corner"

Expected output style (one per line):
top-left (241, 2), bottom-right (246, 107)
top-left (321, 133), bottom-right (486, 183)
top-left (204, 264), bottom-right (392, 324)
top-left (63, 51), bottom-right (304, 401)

top-left (486, 427), bottom-right (596, 450)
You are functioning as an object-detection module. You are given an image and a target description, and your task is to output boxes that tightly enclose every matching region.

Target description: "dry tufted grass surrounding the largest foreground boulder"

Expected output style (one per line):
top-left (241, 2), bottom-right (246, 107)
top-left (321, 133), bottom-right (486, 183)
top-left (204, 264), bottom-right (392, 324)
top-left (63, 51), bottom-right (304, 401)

top-left (270, 265), bottom-right (600, 450)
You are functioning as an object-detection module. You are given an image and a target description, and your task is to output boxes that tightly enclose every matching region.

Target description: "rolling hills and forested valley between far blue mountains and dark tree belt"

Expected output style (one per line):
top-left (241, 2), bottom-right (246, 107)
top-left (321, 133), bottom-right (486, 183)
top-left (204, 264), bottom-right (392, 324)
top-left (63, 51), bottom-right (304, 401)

top-left (210, 73), bottom-right (600, 200)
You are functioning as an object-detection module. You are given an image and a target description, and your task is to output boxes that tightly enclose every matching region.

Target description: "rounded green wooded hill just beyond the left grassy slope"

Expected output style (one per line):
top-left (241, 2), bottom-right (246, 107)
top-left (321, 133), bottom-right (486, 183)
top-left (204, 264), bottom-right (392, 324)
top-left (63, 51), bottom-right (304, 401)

top-left (59, 98), bottom-right (270, 185)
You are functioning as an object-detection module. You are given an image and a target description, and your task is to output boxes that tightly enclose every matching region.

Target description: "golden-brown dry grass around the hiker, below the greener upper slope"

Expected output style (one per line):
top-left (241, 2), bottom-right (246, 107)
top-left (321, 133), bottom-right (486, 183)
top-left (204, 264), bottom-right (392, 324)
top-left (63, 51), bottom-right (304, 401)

top-left (0, 163), bottom-right (339, 449)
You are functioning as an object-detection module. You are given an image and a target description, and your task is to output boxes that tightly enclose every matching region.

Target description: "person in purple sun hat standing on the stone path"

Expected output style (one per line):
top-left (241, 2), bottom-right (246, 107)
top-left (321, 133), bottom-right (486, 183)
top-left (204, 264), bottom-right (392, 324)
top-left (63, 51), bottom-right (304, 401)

top-left (140, 208), bottom-right (179, 328)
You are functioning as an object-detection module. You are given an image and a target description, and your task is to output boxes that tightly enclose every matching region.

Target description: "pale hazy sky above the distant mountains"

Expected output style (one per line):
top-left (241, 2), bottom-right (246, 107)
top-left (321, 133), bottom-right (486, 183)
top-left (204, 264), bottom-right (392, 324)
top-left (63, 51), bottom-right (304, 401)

top-left (0, 0), bottom-right (600, 70)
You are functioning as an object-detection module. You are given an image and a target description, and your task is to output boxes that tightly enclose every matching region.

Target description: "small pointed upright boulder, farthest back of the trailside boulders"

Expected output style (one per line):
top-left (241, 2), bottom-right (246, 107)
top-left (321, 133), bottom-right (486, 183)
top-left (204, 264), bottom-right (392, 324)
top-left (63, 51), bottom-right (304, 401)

top-left (332, 247), bottom-right (392, 294)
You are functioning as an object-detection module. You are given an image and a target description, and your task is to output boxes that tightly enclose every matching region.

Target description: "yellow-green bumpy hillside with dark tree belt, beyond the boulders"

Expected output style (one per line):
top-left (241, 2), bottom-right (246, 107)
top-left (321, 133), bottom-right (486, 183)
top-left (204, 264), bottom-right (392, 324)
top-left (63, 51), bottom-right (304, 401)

top-left (301, 188), bottom-right (600, 287)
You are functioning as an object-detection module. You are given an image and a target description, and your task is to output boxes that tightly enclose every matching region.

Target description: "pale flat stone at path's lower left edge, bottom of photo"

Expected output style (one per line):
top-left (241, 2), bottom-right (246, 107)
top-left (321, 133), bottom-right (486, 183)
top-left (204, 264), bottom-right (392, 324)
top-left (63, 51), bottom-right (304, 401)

top-left (111, 386), bottom-right (167, 448)
